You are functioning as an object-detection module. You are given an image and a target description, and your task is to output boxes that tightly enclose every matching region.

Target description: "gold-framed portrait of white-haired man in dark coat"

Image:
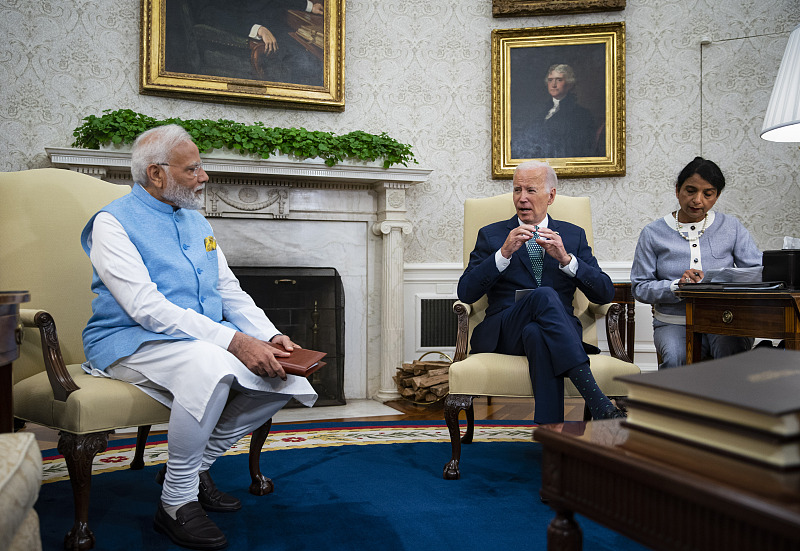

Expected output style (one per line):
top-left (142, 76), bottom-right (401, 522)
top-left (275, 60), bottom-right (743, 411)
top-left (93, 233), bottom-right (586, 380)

top-left (492, 22), bottom-right (625, 178)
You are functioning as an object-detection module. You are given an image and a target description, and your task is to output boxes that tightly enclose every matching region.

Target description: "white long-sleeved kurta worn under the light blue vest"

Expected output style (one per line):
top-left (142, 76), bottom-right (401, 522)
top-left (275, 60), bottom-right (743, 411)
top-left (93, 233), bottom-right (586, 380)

top-left (84, 212), bottom-right (317, 420)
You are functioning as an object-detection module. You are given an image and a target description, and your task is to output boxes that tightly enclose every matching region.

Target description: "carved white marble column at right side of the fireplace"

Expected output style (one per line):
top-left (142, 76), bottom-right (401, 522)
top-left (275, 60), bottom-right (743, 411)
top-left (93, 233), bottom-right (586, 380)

top-left (372, 182), bottom-right (412, 402)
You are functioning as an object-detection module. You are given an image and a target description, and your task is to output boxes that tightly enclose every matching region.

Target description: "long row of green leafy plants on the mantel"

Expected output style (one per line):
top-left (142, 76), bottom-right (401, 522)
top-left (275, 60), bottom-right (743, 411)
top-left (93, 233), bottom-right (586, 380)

top-left (72, 109), bottom-right (417, 168)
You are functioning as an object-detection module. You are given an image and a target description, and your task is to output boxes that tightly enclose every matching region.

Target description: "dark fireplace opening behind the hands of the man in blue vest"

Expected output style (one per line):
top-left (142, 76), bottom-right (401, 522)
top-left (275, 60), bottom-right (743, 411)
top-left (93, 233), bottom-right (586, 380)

top-left (231, 266), bottom-right (346, 407)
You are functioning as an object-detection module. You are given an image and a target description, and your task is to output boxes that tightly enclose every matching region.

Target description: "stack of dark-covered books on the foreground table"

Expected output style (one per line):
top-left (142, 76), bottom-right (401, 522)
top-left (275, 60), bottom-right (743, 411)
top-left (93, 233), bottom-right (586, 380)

top-left (618, 348), bottom-right (800, 499)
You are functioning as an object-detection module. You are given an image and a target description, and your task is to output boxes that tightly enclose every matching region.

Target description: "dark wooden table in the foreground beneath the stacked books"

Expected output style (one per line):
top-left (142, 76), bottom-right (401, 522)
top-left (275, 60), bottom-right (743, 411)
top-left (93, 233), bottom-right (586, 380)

top-left (534, 419), bottom-right (800, 551)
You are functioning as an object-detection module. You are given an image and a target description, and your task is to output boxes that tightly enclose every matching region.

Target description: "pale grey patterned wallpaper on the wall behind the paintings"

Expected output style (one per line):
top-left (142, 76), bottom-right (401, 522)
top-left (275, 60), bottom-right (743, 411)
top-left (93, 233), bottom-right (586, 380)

top-left (0, 0), bottom-right (800, 263)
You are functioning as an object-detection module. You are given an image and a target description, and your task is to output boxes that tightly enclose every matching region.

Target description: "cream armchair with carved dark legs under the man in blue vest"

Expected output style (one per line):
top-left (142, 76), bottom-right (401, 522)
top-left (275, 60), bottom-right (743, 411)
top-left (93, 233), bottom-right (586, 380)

top-left (0, 169), bottom-right (273, 549)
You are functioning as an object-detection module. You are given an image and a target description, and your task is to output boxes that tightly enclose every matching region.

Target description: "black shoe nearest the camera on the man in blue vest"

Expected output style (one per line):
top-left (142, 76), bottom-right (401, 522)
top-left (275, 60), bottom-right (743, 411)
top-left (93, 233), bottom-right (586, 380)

top-left (153, 501), bottom-right (228, 549)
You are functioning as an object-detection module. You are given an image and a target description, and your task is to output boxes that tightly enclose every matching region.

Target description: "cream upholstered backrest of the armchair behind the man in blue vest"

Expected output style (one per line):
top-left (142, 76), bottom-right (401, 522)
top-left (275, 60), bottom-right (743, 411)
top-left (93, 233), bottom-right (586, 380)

top-left (0, 168), bottom-right (130, 382)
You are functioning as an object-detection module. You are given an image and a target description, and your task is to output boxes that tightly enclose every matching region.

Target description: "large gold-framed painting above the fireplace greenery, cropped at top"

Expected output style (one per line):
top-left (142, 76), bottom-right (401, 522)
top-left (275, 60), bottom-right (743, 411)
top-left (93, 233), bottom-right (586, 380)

top-left (139, 0), bottom-right (345, 111)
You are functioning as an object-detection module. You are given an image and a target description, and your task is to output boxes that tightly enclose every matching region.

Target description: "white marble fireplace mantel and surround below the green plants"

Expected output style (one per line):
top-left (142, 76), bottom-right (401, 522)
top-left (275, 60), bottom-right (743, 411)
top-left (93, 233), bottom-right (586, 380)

top-left (46, 147), bottom-right (431, 401)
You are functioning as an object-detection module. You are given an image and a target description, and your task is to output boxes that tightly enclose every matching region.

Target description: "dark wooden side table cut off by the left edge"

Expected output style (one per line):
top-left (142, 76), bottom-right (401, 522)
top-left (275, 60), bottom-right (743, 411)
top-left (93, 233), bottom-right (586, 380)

top-left (0, 291), bottom-right (31, 432)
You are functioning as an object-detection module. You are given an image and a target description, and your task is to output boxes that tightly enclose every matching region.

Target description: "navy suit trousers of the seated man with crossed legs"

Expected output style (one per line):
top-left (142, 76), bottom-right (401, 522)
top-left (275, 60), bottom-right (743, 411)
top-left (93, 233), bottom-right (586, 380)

top-left (496, 287), bottom-right (589, 424)
